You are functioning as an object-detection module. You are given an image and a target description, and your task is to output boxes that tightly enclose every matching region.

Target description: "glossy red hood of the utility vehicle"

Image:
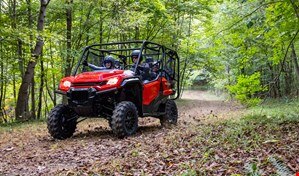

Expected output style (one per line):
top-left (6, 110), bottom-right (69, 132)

top-left (72, 70), bottom-right (124, 83)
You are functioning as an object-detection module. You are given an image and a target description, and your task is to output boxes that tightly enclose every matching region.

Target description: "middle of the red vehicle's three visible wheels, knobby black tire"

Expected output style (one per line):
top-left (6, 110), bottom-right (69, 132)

top-left (110, 101), bottom-right (138, 138)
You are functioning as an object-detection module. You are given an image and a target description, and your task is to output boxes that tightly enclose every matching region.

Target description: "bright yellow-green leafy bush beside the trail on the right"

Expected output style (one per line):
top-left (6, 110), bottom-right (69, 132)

top-left (227, 72), bottom-right (265, 106)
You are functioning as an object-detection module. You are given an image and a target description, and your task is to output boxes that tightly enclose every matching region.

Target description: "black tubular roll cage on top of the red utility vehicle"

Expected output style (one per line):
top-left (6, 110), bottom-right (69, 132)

top-left (72, 40), bottom-right (180, 99)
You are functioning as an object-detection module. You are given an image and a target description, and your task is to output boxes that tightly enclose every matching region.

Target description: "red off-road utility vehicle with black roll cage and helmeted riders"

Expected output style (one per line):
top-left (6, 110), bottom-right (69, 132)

top-left (47, 41), bottom-right (180, 139)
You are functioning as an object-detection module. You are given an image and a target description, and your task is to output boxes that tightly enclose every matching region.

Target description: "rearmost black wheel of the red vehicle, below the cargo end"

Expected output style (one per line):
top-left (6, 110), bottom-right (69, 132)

top-left (160, 100), bottom-right (178, 126)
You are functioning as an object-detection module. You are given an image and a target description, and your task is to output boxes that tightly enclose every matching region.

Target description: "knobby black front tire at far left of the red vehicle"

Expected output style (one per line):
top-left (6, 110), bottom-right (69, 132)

top-left (47, 104), bottom-right (78, 139)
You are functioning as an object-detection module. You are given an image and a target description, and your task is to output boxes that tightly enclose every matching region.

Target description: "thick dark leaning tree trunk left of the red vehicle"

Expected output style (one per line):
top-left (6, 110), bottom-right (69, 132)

top-left (16, 0), bottom-right (50, 121)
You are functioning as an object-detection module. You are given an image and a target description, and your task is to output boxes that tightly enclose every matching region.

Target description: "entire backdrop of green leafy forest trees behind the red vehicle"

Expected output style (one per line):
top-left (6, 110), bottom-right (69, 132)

top-left (0, 0), bottom-right (299, 123)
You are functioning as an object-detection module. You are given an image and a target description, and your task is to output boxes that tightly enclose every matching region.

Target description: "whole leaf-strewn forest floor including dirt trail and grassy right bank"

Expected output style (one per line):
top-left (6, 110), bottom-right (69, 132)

top-left (0, 91), bottom-right (299, 176)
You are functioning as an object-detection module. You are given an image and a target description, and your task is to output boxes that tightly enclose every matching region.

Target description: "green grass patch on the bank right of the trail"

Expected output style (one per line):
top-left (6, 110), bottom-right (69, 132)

top-left (210, 99), bottom-right (299, 142)
